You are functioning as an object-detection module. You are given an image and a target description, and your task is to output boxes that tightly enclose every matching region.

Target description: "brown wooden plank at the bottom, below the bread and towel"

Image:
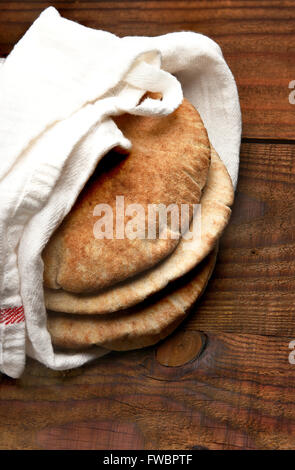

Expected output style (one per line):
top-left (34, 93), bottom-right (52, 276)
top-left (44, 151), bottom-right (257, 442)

top-left (0, 333), bottom-right (295, 449)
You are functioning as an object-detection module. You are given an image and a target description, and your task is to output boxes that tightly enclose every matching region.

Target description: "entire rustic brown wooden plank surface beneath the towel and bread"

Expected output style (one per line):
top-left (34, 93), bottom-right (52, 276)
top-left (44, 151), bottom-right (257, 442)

top-left (0, 1), bottom-right (295, 449)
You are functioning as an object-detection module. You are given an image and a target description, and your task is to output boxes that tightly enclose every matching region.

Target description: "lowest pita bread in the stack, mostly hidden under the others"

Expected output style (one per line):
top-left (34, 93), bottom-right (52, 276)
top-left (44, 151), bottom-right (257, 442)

top-left (47, 249), bottom-right (217, 351)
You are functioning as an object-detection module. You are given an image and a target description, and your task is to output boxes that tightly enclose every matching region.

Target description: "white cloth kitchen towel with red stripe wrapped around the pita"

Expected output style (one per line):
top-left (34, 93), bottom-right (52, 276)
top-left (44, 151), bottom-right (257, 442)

top-left (0, 7), bottom-right (241, 377)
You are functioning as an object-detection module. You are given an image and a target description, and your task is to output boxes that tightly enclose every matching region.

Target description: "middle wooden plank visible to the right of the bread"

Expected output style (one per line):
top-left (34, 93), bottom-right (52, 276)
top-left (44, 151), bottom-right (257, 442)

top-left (187, 143), bottom-right (295, 338)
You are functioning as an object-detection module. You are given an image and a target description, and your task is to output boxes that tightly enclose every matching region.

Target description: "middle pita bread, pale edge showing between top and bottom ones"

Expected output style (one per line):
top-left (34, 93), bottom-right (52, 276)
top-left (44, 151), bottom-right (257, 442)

top-left (45, 148), bottom-right (234, 314)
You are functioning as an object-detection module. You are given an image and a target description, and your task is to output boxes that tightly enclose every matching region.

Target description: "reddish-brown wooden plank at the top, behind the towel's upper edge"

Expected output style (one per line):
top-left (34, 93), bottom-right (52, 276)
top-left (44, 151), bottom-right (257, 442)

top-left (0, 0), bottom-right (295, 139)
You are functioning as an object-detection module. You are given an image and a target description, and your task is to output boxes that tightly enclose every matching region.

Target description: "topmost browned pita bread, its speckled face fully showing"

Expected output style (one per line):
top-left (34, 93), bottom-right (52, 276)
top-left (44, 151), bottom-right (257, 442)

top-left (42, 99), bottom-right (210, 293)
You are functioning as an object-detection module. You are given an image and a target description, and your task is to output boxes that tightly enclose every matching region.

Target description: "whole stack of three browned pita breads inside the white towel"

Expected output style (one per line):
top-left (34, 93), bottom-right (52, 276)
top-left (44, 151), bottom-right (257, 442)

top-left (43, 99), bottom-right (234, 351)
